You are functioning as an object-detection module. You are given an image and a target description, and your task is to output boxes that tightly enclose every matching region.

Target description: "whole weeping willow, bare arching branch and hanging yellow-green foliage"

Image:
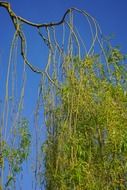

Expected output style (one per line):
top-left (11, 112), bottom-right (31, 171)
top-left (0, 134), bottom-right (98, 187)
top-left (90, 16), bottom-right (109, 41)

top-left (0, 1), bottom-right (127, 190)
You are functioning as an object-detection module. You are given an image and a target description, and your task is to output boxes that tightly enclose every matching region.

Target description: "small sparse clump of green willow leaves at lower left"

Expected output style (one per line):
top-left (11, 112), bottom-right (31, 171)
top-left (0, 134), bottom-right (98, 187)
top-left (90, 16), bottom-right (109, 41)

top-left (0, 119), bottom-right (31, 187)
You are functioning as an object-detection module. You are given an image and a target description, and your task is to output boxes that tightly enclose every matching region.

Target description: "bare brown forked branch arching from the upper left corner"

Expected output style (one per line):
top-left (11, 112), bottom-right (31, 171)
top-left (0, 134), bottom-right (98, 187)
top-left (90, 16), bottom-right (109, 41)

top-left (0, 1), bottom-right (98, 87)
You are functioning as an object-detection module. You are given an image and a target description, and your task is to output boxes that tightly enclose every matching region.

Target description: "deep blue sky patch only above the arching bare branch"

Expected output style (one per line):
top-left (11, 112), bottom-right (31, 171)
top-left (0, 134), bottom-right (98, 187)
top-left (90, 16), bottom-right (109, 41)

top-left (7, 0), bottom-right (127, 49)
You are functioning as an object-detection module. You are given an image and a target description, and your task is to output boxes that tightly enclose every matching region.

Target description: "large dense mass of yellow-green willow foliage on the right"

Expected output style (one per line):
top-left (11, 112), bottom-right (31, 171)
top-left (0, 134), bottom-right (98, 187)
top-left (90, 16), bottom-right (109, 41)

top-left (42, 49), bottom-right (127, 190)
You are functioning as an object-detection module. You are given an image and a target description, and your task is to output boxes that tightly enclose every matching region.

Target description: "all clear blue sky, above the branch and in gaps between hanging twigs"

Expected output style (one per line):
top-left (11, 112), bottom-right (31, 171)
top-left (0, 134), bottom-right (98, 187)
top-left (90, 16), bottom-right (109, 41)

top-left (0, 0), bottom-right (127, 190)
